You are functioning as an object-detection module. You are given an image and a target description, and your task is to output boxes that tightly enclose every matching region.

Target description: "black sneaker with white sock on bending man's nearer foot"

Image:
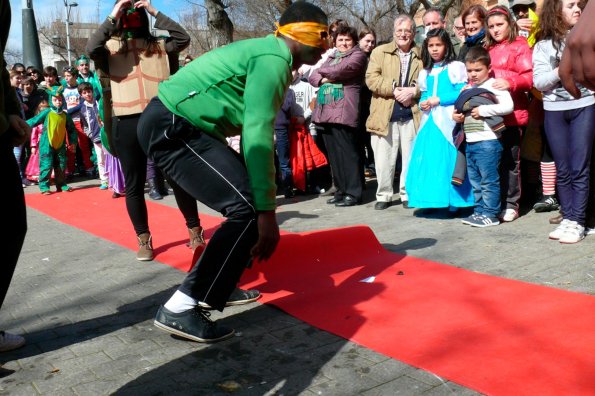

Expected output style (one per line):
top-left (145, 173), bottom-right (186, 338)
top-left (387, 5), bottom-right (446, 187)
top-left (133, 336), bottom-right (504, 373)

top-left (153, 306), bottom-right (234, 342)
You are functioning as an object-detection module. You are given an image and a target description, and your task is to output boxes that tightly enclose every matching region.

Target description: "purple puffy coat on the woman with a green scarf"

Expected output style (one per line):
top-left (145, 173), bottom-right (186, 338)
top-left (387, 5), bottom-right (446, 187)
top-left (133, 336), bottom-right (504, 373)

top-left (308, 45), bottom-right (368, 128)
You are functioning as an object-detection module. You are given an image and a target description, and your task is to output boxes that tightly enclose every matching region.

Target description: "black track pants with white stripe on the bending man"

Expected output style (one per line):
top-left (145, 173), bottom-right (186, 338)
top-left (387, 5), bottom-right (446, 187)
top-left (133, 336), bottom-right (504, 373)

top-left (138, 98), bottom-right (258, 310)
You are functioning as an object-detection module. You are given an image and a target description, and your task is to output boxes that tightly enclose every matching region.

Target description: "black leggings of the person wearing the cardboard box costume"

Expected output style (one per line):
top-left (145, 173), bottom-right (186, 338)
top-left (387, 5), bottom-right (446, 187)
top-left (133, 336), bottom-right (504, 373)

top-left (112, 114), bottom-right (200, 235)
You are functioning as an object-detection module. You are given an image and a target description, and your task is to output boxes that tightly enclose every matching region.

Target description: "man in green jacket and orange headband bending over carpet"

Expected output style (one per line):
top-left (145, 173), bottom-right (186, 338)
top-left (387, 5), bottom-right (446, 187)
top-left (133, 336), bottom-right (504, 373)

top-left (138, 1), bottom-right (328, 342)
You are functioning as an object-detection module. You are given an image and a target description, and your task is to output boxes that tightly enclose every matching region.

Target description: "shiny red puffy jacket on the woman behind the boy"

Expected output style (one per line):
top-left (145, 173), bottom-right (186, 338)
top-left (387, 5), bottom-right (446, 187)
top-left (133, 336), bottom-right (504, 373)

top-left (488, 36), bottom-right (533, 126)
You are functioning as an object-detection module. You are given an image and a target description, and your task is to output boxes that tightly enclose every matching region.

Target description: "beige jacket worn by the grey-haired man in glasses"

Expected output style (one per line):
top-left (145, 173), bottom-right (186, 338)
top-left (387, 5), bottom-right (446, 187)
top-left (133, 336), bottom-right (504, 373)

top-left (366, 40), bottom-right (422, 136)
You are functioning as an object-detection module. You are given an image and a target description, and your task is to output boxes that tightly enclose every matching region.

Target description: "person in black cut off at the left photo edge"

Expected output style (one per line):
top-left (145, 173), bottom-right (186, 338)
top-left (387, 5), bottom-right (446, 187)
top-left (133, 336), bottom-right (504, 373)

top-left (0, 1), bottom-right (31, 352)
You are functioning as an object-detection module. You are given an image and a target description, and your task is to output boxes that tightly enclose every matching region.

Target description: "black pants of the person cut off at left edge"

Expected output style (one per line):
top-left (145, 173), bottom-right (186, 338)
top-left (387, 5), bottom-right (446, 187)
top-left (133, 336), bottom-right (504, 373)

top-left (0, 132), bottom-right (27, 307)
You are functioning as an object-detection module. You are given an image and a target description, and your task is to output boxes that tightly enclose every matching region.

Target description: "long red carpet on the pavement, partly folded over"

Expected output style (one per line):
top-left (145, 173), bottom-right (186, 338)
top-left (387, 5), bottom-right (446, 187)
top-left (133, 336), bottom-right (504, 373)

top-left (27, 189), bottom-right (595, 395)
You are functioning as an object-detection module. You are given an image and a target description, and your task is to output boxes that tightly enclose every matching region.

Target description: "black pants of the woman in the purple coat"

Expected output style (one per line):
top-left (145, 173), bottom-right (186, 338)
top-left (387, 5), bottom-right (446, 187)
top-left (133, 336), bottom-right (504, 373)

top-left (321, 124), bottom-right (363, 202)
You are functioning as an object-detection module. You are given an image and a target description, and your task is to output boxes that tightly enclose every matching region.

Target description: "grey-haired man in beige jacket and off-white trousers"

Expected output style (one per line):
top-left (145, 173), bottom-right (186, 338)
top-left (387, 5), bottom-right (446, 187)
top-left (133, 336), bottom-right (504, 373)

top-left (366, 14), bottom-right (422, 210)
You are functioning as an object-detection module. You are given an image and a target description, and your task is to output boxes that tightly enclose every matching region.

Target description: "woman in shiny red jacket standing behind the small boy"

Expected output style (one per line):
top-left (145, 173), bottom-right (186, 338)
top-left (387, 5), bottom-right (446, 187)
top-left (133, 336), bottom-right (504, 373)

top-left (485, 5), bottom-right (533, 221)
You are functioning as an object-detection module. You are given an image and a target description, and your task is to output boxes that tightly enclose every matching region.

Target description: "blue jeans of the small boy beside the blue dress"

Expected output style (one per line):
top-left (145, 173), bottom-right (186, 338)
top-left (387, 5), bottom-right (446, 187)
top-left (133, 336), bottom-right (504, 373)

top-left (466, 139), bottom-right (502, 217)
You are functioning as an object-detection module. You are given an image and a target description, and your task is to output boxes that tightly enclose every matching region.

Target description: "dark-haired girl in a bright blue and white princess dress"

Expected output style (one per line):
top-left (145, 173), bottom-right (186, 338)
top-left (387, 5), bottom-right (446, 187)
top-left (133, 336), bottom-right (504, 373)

top-left (405, 29), bottom-right (473, 211)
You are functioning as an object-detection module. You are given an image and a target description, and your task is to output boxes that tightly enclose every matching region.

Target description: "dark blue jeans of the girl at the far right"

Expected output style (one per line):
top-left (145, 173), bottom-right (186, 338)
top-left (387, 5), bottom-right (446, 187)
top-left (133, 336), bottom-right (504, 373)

top-left (544, 105), bottom-right (595, 225)
